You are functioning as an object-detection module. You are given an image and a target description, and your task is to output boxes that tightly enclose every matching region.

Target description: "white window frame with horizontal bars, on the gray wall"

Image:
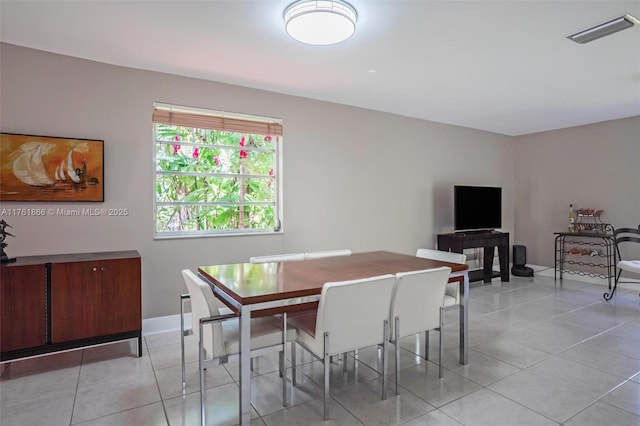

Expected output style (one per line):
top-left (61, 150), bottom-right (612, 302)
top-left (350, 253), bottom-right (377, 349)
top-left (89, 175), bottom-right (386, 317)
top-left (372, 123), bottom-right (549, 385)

top-left (151, 102), bottom-right (284, 240)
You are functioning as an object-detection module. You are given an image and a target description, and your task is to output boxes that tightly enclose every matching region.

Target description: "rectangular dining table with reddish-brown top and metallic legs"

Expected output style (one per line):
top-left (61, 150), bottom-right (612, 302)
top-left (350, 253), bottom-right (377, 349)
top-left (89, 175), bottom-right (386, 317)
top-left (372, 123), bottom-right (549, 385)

top-left (198, 251), bottom-right (469, 425)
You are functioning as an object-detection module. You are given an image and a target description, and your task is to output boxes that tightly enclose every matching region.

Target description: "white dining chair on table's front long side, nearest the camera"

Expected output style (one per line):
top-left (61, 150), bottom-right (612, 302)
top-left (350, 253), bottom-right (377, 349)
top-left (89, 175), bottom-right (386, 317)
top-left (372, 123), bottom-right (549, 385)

top-left (290, 275), bottom-right (395, 420)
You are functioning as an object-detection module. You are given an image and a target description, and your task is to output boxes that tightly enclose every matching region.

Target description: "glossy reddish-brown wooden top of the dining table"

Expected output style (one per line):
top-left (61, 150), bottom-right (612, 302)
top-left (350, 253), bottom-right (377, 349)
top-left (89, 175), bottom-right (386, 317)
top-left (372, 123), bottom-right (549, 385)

top-left (198, 251), bottom-right (468, 305)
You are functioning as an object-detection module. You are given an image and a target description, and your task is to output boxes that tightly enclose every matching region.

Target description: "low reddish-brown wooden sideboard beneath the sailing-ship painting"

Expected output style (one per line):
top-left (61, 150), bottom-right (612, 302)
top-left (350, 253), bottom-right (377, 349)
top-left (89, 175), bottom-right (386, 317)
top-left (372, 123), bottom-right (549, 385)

top-left (0, 251), bottom-right (142, 361)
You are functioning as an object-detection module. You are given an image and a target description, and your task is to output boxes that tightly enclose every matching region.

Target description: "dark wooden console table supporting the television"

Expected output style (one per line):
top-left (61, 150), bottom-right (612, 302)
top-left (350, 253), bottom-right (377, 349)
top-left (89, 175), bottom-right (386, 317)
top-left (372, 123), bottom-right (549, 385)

top-left (438, 231), bottom-right (509, 283)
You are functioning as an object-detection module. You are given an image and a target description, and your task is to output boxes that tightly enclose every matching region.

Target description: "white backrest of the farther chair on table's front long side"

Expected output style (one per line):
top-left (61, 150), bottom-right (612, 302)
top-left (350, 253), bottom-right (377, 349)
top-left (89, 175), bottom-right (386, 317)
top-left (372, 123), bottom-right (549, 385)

top-left (389, 266), bottom-right (451, 340)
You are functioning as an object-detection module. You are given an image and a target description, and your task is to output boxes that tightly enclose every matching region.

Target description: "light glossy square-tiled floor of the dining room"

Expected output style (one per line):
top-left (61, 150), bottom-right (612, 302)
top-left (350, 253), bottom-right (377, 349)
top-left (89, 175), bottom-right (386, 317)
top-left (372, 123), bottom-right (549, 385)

top-left (0, 277), bottom-right (640, 426)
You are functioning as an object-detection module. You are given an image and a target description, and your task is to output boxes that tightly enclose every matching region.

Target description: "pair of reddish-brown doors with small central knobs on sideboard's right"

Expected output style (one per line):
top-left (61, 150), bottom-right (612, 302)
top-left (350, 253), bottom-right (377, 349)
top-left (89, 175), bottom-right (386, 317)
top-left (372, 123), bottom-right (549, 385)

top-left (51, 258), bottom-right (142, 343)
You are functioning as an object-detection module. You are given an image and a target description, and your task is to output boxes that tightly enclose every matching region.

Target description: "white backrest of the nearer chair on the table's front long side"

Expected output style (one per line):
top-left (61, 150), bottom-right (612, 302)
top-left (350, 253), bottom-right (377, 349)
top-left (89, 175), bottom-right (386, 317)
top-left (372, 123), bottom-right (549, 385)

top-left (314, 274), bottom-right (395, 355)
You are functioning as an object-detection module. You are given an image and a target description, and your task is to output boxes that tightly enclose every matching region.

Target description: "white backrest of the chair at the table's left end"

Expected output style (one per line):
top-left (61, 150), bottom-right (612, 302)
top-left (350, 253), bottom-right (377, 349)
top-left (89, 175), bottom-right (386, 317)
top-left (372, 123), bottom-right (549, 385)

top-left (182, 269), bottom-right (226, 358)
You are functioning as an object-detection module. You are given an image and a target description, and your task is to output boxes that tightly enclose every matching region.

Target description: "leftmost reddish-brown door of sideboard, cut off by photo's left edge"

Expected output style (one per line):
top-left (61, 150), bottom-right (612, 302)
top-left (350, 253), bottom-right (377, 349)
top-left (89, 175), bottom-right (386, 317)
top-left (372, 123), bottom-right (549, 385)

top-left (0, 264), bottom-right (47, 352)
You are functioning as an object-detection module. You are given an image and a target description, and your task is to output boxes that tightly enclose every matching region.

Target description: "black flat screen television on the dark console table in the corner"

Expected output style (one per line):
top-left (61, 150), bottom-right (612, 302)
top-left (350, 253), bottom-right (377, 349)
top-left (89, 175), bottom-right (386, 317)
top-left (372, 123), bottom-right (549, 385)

top-left (453, 185), bottom-right (502, 231)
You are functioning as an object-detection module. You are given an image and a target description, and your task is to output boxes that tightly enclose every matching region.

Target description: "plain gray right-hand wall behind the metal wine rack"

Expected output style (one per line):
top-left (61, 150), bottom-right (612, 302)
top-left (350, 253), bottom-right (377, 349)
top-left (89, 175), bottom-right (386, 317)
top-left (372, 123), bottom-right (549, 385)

top-left (512, 117), bottom-right (640, 266)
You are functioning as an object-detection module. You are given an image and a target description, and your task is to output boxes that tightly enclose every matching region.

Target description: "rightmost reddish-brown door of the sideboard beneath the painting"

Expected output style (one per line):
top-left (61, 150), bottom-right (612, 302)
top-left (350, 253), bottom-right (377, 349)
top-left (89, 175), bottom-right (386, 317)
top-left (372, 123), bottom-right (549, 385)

top-left (97, 258), bottom-right (142, 335)
